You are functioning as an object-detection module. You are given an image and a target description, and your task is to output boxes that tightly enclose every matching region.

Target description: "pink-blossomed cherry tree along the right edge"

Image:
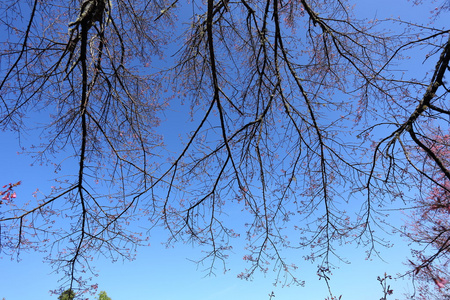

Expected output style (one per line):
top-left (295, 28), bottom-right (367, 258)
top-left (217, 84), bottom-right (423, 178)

top-left (405, 132), bottom-right (450, 299)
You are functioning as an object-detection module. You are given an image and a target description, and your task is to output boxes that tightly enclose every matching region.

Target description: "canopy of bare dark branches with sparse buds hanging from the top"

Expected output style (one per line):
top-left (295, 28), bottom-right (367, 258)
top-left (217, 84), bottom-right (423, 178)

top-left (0, 0), bottom-right (450, 296)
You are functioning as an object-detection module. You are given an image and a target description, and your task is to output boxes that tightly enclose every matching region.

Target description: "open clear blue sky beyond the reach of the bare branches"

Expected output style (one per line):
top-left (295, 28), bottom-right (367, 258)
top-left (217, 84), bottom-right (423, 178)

top-left (0, 0), bottom-right (446, 300)
